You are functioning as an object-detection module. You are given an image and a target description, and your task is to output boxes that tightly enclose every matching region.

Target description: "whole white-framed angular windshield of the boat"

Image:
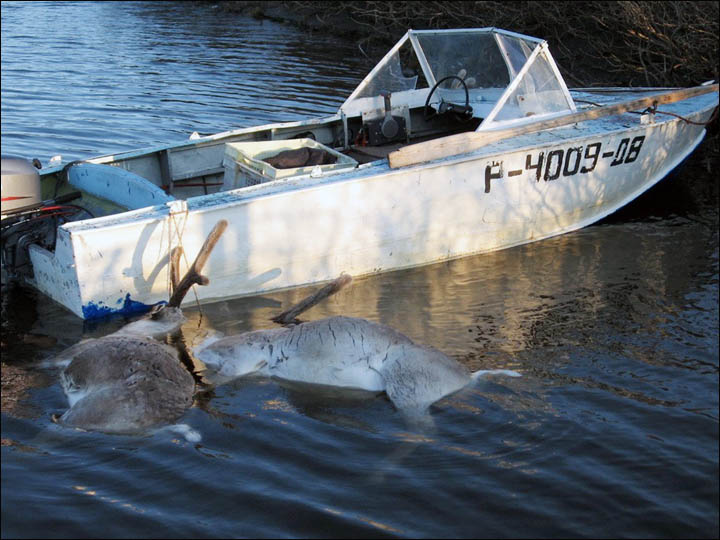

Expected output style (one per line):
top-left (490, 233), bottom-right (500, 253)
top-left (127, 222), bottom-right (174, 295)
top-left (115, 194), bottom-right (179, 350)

top-left (340, 28), bottom-right (575, 130)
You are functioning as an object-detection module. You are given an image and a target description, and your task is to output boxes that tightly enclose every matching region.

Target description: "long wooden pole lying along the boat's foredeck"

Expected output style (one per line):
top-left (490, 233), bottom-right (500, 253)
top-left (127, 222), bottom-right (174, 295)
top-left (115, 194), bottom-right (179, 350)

top-left (388, 84), bottom-right (718, 169)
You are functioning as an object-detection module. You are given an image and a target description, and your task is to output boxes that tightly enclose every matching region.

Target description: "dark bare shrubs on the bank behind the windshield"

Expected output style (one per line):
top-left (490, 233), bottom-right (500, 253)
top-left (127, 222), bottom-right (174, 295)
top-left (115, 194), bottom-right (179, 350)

top-left (276, 1), bottom-right (720, 86)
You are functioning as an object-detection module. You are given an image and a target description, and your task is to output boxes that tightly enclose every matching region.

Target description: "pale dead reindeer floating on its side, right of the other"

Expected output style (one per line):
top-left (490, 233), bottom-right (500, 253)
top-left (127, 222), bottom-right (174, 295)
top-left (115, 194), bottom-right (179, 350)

top-left (194, 276), bottom-right (519, 425)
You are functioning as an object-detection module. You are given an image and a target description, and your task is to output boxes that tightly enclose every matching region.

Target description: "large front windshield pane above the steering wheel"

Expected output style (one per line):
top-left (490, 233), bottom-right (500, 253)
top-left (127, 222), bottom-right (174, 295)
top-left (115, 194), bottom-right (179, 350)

top-left (417, 32), bottom-right (510, 89)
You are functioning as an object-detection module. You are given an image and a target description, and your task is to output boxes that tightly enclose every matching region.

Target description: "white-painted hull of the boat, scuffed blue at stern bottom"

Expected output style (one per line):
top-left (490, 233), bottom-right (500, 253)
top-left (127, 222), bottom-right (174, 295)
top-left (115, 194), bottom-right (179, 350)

top-left (25, 96), bottom-right (716, 319)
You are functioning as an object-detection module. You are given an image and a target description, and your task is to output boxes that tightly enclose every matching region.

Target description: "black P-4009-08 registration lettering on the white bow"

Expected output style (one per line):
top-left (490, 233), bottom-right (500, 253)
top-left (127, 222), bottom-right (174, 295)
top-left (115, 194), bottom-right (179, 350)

top-left (485, 135), bottom-right (645, 193)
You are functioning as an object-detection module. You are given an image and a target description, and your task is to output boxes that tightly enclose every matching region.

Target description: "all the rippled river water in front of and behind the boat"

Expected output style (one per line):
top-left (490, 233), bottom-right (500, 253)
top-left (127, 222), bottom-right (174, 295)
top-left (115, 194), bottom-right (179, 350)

top-left (2, 2), bottom-right (720, 538)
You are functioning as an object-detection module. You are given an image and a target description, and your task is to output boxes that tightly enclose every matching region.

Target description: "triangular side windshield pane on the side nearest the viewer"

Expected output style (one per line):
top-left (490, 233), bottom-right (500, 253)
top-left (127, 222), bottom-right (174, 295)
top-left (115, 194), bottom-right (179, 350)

top-left (494, 51), bottom-right (570, 122)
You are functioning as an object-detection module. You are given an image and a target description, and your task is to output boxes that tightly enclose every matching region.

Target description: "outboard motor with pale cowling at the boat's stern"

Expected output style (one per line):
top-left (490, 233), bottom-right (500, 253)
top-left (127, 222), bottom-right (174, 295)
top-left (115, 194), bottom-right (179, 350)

top-left (0, 156), bottom-right (85, 282)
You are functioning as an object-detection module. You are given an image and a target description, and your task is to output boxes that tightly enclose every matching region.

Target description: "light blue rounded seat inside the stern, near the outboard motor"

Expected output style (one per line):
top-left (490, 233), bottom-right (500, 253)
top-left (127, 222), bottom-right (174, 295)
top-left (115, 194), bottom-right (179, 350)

top-left (68, 163), bottom-right (175, 210)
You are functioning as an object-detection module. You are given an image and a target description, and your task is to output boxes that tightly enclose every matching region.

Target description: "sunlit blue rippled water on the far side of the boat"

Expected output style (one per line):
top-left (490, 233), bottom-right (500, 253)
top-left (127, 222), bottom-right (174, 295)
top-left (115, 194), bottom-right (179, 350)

top-left (2, 2), bottom-right (369, 162)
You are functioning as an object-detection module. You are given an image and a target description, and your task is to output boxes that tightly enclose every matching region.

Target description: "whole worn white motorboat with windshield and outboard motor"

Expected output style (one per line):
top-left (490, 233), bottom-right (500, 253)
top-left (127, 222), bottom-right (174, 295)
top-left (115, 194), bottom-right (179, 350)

top-left (2, 28), bottom-right (718, 319)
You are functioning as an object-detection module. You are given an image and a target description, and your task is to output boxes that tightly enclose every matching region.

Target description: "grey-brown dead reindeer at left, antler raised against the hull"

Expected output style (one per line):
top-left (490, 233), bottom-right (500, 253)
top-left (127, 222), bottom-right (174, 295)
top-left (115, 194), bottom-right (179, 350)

top-left (53, 220), bottom-right (227, 440)
